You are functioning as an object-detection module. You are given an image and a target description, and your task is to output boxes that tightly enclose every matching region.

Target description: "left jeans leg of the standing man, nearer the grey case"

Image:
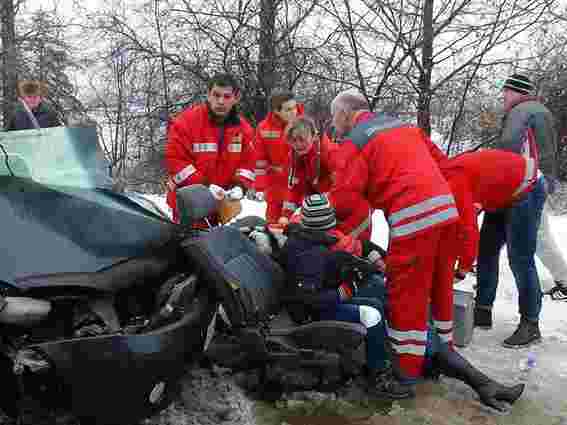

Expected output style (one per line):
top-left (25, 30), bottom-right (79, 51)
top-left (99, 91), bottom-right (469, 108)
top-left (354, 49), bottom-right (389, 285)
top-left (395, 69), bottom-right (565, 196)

top-left (474, 212), bottom-right (506, 328)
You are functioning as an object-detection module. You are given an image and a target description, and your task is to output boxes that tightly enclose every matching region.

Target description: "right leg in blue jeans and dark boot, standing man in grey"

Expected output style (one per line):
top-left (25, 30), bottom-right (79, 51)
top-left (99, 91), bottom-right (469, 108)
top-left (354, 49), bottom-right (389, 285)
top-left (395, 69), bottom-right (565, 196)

top-left (504, 177), bottom-right (546, 347)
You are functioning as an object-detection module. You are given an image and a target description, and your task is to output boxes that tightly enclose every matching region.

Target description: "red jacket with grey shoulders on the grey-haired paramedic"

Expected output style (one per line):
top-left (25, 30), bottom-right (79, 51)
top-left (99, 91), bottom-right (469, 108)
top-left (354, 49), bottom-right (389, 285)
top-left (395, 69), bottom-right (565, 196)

top-left (331, 112), bottom-right (458, 241)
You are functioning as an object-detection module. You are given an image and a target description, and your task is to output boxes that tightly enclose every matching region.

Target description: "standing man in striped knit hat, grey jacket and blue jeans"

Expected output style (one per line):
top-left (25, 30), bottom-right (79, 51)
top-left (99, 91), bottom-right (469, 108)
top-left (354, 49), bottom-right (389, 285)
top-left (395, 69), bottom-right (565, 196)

top-left (475, 74), bottom-right (557, 348)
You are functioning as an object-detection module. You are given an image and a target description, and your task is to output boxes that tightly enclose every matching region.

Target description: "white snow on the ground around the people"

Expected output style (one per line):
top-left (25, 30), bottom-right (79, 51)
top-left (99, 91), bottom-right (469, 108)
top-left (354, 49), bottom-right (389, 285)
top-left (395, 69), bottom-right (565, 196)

top-left (145, 195), bottom-right (567, 425)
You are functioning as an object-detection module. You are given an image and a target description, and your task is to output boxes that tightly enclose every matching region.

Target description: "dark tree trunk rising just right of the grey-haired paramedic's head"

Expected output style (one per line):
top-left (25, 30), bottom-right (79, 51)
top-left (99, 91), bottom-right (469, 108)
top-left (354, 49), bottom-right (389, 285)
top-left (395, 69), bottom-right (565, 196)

top-left (417, 0), bottom-right (433, 134)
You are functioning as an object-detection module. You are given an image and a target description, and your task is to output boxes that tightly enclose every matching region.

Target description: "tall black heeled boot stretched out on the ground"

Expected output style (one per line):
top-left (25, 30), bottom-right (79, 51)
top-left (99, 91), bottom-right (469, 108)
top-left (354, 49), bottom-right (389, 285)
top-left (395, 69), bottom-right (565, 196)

top-left (433, 351), bottom-right (524, 411)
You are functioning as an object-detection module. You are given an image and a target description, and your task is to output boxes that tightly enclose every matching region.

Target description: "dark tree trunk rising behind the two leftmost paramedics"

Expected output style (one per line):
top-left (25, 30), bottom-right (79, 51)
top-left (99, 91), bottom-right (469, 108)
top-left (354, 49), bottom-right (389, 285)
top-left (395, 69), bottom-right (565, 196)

top-left (254, 0), bottom-right (278, 121)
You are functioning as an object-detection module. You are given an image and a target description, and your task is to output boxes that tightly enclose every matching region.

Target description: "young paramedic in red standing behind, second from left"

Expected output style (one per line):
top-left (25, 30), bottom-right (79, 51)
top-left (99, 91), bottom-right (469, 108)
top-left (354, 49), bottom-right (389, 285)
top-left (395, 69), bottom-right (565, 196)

top-left (254, 92), bottom-right (303, 223)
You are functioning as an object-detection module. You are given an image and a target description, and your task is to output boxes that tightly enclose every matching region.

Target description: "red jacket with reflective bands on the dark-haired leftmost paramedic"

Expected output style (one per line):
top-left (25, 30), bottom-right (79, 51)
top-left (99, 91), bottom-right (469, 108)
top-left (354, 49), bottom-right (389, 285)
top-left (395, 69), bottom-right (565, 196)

top-left (165, 104), bottom-right (255, 215)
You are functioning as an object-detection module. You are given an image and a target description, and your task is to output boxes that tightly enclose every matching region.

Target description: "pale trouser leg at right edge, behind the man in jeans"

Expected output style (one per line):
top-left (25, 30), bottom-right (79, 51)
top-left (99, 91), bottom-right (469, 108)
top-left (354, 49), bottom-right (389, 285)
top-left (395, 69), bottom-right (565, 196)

top-left (536, 201), bottom-right (567, 289)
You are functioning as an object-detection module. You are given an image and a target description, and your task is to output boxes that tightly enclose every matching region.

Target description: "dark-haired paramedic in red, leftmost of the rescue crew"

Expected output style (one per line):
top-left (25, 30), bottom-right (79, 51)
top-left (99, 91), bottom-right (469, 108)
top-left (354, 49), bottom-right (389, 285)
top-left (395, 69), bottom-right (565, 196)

top-left (165, 74), bottom-right (255, 221)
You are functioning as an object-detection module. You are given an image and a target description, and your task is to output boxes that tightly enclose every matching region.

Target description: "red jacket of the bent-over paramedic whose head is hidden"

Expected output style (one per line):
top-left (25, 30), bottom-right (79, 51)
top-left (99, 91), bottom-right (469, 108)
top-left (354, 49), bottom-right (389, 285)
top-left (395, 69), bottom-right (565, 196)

top-left (441, 149), bottom-right (538, 272)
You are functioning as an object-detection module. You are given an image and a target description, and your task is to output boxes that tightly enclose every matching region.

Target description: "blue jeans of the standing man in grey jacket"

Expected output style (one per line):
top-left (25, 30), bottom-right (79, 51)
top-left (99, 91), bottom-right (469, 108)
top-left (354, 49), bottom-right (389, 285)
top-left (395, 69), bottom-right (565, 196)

top-left (476, 177), bottom-right (547, 322)
